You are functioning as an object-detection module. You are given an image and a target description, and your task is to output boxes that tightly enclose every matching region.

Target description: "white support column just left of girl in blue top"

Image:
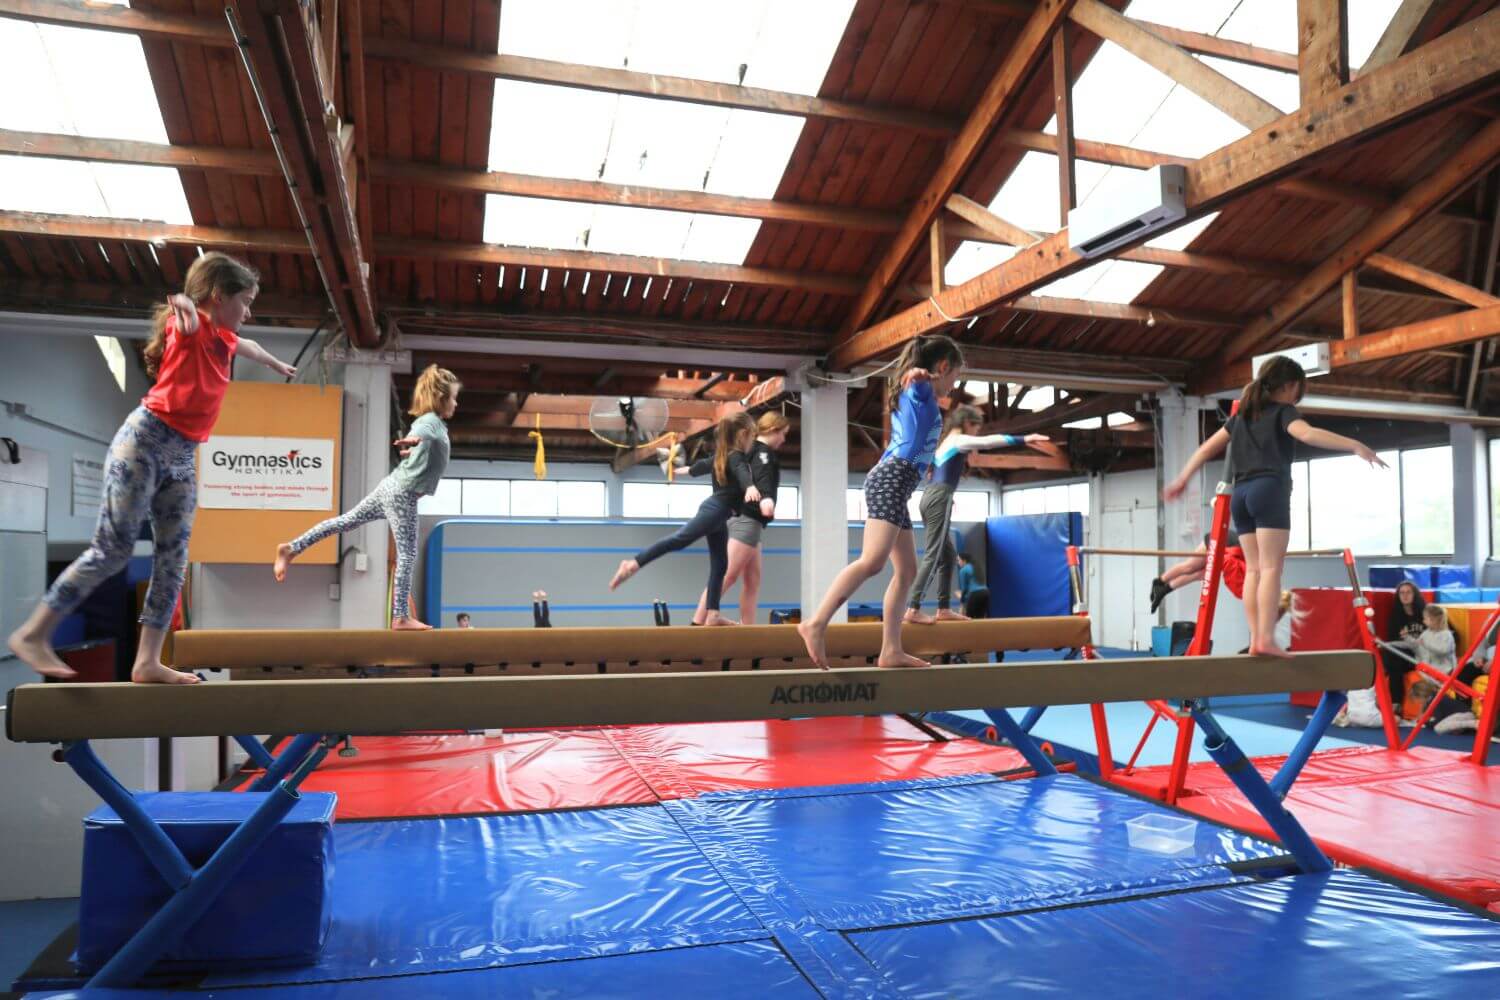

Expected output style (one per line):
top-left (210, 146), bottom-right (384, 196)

top-left (801, 385), bottom-right (849, 622)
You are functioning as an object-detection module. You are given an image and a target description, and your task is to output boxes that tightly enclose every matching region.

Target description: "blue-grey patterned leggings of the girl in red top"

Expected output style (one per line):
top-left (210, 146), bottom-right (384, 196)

top-left (42, 406), bottom-right (198, 628)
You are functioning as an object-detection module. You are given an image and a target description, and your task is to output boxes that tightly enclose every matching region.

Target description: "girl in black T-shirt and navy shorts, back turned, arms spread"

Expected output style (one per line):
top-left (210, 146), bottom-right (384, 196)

top-left (1163, 357), bottom-right (1386, 657)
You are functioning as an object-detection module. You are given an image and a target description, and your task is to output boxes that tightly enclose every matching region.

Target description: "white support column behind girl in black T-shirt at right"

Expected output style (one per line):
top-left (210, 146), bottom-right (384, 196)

top-left (1157, 391), bottom-right (1224, 622)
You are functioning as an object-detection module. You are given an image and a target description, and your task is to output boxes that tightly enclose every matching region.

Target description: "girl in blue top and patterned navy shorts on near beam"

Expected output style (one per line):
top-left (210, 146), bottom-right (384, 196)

top-left (797, 336), bottom-right (963, 669)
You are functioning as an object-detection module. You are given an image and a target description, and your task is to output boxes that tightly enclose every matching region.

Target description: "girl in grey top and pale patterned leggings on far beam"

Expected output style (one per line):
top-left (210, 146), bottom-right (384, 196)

top-left (273, 364), bottom-right (462, 631)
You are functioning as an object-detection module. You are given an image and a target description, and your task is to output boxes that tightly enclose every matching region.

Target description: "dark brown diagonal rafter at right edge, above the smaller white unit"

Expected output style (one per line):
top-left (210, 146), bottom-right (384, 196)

top-left (1217, 116), bottom-right (1500, 364)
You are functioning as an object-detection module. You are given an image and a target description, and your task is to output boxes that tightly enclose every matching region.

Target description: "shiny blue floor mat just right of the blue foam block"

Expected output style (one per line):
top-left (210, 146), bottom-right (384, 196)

top-left (206, 805), bottom-right (767, 987)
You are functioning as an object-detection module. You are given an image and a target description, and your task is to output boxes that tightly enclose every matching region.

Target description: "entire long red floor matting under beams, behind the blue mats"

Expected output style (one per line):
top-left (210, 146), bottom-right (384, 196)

top-left (252, 717), bottom-right (1026, 820)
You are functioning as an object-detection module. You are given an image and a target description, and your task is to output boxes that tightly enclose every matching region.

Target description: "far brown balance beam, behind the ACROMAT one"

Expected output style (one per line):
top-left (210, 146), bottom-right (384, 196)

top-left (173, 615), bottom-right (1091, 671)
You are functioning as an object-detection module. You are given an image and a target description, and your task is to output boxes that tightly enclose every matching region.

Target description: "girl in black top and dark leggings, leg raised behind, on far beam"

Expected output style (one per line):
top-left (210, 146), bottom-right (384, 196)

top-left (609, 411), bottom-right (762, 625)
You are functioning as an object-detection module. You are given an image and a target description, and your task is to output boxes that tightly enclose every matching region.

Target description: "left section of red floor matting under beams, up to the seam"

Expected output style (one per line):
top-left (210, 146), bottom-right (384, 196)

top-left (282, 729), bottom-right (657, 820)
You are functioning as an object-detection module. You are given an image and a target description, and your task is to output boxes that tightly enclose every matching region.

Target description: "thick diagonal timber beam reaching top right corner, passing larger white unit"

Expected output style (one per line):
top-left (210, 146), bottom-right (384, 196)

top-left (830, 10), bottom-right (1500, 370)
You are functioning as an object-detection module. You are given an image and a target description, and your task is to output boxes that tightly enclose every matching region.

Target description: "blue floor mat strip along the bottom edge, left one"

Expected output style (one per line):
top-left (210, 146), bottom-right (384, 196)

top-left (27, 942), bottom-right (819, 1000)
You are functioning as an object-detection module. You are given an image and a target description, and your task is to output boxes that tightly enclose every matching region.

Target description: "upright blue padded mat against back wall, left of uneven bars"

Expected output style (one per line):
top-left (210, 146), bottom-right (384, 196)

top-left (986, 513), bottom-right (1083, 618)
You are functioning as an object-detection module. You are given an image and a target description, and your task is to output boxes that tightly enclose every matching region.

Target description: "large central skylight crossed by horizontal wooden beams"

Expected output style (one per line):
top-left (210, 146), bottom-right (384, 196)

top-left (485, 0), bottom-right (854, 264)
